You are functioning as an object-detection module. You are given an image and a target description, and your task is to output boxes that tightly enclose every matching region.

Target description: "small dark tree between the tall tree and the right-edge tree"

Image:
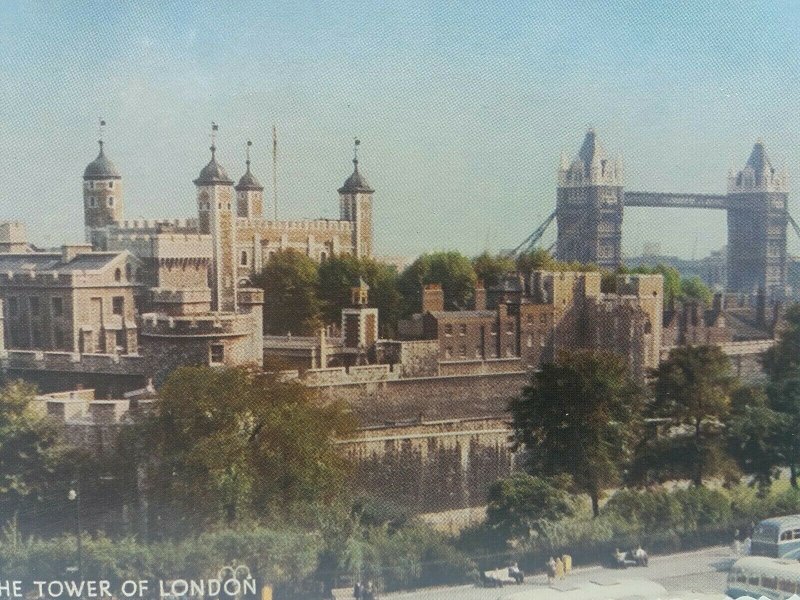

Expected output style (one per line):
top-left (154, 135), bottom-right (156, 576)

top-left (725, 386), bottom-right (783, 497)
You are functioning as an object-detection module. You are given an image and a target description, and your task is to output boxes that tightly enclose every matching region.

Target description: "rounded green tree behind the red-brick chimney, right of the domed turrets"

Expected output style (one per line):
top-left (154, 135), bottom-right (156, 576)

top-left (398, 252), bottom-right (478, 315)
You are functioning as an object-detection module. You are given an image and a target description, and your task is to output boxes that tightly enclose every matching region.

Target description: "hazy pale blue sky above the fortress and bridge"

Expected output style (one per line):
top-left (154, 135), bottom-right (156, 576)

top-left (0, 0), bottom-right (800, 256)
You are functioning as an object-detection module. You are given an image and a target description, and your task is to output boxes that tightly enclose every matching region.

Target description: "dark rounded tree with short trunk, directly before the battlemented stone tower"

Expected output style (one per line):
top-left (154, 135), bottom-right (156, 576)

top-left (510, 351), bottom-right (642, 516)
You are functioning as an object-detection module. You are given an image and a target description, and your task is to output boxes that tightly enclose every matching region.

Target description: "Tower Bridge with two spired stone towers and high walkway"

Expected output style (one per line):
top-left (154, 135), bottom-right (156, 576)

top-left (516, 129), bottom-right (788, 297)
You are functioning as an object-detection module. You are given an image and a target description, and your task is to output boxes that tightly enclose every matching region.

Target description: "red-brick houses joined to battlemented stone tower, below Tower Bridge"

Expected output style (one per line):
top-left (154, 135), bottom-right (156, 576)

top-left (399, 271), bottom-right (663, 378)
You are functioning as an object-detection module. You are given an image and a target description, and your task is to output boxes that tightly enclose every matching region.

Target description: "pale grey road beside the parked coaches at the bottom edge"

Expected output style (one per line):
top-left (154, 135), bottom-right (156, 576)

top-left (382, 546), bottom-right (734, 600)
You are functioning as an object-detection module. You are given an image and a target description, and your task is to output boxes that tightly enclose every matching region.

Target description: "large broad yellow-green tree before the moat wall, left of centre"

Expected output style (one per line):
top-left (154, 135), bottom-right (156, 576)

top-left (142, 367), bottom-right (352, 533)
